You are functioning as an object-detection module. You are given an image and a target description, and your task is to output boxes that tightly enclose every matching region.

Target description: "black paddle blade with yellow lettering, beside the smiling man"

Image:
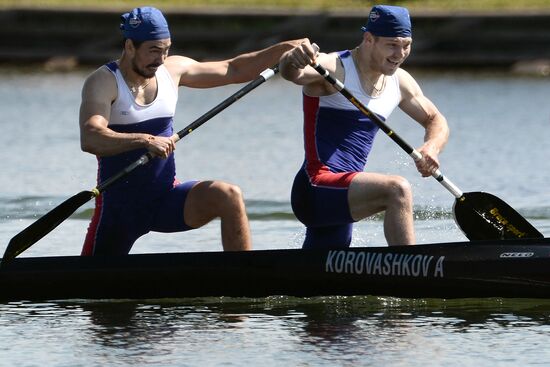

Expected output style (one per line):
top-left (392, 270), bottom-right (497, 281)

top-left (453, 192), bottom-right (544, 241)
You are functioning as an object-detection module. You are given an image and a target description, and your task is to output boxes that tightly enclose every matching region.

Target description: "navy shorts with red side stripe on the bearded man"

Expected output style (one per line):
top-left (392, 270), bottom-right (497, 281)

top-left (82, 181), bottom-right (198, 255)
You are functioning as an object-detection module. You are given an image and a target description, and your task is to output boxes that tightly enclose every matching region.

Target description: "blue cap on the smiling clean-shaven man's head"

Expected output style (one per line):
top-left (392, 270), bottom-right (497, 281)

top-left (361, 5), bottom-right (412, 37)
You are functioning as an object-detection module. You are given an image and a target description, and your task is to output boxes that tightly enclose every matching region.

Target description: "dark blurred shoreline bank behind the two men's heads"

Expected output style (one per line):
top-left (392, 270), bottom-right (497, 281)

top-left (0, 8), bottom-right (550, 73)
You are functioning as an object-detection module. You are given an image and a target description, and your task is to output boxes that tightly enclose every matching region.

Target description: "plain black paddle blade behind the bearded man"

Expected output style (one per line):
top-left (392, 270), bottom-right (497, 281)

top-left (1, 191), bottom-right (94, 265)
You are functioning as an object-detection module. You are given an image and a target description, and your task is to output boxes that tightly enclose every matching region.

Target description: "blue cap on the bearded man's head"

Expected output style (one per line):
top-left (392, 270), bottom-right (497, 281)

top-left (120, 6), bottom-right (170, 41)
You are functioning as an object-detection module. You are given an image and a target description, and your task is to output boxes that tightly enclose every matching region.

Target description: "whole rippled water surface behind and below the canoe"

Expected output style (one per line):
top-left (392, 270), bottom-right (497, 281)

top-left (0, 70), bottom-right (550, 366)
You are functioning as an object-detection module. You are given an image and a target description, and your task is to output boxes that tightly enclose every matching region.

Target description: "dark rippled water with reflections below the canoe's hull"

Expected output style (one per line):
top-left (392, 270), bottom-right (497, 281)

top-left (0, 297), bottom-right (550, 366)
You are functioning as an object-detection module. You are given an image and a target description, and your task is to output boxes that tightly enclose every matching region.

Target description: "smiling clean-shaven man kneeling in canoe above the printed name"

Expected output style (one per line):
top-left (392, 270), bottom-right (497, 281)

top-left (280, 5), bottom-right (449, 248)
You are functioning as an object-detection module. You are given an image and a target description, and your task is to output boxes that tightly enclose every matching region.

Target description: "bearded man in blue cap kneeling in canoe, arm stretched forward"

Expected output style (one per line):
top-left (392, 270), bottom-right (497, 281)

top-left (80, 7), bottom-right (303, 255)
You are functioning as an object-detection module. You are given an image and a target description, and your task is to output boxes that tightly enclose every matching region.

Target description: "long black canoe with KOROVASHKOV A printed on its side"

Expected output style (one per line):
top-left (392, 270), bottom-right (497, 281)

top-left (0, 238), bottom-right (550, 302)
